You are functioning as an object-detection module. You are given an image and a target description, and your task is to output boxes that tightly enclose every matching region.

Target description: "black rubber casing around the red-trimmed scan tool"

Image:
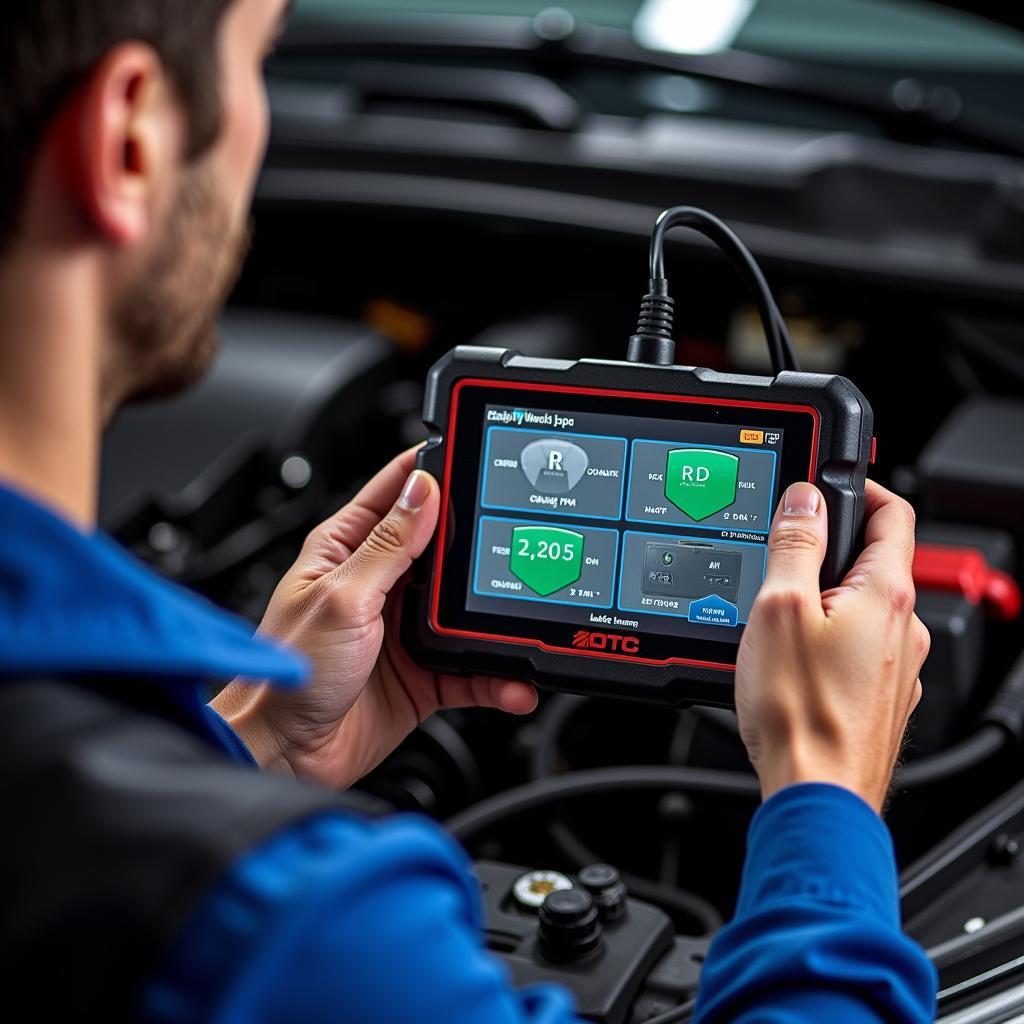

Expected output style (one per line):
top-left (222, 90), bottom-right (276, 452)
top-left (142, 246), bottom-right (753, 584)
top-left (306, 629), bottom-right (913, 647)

top-left (402, 346), bottom-right (873, 708)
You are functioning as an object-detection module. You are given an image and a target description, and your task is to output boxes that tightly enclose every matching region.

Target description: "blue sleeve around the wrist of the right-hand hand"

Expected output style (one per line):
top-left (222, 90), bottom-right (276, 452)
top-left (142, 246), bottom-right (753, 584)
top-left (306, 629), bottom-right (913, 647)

top-left (694, 784), bottom-right (937, 1024)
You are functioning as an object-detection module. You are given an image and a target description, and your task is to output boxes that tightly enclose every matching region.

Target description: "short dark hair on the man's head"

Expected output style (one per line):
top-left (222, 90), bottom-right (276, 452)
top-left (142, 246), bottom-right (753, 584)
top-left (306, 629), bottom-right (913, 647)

top-left (0, 0), bottom-right (234, 254)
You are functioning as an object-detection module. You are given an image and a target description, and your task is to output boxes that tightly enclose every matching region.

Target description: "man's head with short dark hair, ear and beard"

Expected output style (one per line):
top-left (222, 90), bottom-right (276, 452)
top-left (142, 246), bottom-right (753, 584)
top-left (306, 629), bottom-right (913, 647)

top-left (0, 0), bottom-right (289, 409)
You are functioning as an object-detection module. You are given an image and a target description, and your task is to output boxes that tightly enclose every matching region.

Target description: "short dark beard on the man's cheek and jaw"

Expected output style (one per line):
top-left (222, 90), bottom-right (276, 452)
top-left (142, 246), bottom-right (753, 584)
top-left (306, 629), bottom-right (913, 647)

top-left (105, 161), bottom-right (252, 406)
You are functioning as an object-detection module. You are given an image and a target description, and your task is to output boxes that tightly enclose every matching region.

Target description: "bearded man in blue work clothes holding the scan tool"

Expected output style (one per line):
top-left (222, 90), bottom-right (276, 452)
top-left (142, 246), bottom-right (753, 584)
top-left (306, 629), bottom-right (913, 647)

top-left (0, 0), bottom-right (935, 1024)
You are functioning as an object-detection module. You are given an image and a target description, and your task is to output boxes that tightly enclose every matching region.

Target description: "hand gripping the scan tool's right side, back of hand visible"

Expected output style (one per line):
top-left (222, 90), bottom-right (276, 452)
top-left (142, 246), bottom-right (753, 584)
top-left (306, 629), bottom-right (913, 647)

top-left (736, 481), bottom-right (931, 810)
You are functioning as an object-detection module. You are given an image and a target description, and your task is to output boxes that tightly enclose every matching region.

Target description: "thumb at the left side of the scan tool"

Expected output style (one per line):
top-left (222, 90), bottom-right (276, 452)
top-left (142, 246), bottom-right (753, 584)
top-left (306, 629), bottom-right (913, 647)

top-left (336, 469), bottom-right (439, 614)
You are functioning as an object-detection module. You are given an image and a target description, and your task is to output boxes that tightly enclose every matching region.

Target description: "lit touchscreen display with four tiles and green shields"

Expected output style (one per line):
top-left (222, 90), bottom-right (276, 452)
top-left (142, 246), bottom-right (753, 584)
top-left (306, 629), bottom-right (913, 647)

top-left (432, 380), bottom-right (811, 660)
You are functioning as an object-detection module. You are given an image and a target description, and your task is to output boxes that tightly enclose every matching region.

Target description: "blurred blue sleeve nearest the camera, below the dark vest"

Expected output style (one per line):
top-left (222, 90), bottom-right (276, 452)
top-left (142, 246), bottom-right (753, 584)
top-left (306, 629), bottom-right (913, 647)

top-left (140, 815), bottom-right (577, 1024)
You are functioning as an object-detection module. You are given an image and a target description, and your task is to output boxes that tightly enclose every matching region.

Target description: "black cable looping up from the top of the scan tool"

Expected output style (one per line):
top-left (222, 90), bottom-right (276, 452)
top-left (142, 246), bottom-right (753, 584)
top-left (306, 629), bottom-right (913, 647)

top-left (628, 206), bottom-right (800, 375)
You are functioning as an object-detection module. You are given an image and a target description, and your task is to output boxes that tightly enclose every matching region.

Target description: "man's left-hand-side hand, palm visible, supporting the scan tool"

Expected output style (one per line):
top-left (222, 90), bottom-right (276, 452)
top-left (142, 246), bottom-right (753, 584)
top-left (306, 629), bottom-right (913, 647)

top-left (213, 451), bottom-right (537, 787)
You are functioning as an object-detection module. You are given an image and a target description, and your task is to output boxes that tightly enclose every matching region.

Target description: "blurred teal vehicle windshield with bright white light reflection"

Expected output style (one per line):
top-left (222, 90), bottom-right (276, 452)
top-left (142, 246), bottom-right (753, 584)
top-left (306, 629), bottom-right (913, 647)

top-left (298, 0), bottom-right (1024, 73)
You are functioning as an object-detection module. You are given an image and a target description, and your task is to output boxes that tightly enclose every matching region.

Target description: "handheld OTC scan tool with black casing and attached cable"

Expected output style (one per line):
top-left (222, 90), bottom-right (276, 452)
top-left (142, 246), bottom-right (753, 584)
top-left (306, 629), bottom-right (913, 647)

top-left (403, 207), bottom-right (872, 707)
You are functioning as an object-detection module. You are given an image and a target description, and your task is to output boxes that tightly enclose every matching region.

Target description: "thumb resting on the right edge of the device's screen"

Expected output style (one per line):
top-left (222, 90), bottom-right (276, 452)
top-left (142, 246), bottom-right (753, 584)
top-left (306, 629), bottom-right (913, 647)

top-left (764, 483), bottom-right (828, 594)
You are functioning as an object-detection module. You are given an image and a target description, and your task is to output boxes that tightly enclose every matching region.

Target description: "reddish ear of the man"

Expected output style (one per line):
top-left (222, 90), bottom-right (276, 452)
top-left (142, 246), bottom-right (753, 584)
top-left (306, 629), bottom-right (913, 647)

top-left (54, 42), bottom-right (184, 246)
